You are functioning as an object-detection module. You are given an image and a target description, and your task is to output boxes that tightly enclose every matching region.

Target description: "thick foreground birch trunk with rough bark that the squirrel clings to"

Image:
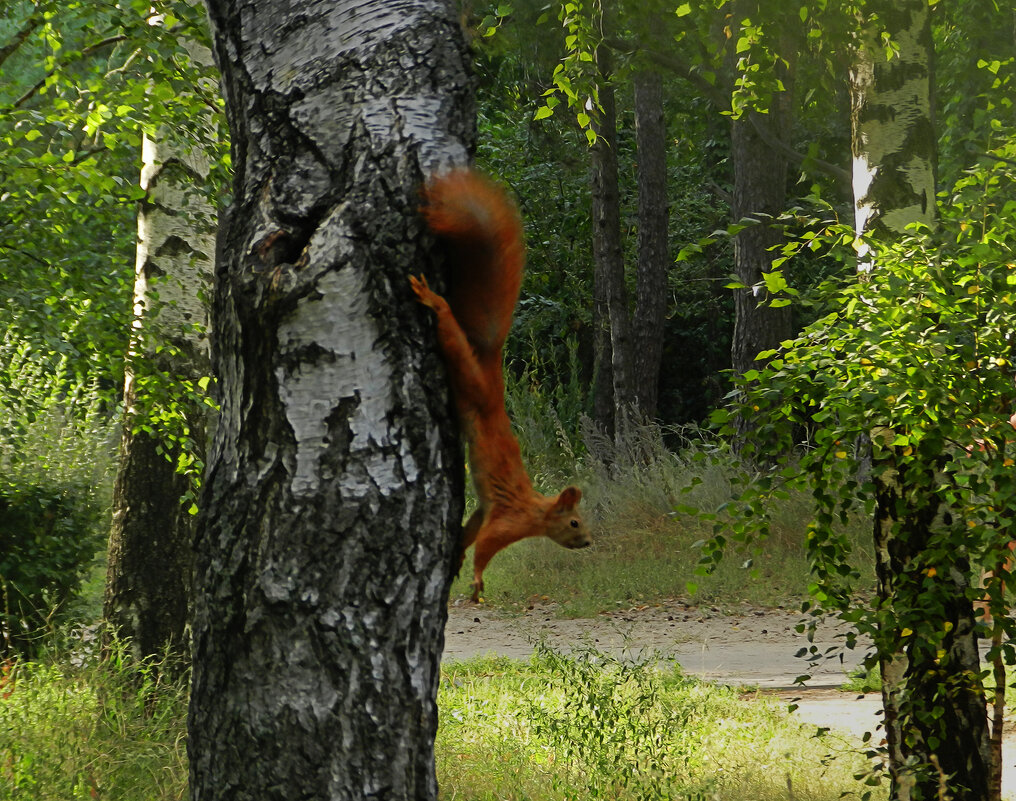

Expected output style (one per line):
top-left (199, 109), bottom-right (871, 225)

top-left (188, 0), bottom-right (473, 801)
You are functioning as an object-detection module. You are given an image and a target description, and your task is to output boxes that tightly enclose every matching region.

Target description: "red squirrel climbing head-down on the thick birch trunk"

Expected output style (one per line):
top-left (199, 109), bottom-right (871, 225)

top-left (409, 169), bottom-right (590, 602)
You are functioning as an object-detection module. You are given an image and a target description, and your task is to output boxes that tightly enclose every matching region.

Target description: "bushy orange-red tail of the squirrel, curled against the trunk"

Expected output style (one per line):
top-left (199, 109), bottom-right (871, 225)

top-left (422, 170), bottom-right (525, 367)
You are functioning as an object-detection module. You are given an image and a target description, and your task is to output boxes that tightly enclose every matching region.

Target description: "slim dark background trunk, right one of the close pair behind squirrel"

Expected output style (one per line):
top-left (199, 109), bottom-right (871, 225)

top-left (632, 70), bottom-right (668, 418)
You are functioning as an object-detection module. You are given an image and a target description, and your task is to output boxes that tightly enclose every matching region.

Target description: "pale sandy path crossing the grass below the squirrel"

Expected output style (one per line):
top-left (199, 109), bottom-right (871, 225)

top-left (443, 602), bottom-right (1016, 798)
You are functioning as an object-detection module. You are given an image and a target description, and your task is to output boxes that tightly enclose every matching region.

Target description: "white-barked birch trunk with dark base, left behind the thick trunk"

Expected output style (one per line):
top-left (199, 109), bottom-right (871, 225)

top-left (104, 32), bottom-right (215, 657)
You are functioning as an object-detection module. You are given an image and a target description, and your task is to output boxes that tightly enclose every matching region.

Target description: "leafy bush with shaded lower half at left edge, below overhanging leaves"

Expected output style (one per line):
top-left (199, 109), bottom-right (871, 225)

top-left (0, 337), bottom-right (116, 653)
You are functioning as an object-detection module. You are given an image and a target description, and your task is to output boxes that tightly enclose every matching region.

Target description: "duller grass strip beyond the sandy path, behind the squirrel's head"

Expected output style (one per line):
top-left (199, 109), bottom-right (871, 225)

top-left (452, 441), bottom-right (873, 617)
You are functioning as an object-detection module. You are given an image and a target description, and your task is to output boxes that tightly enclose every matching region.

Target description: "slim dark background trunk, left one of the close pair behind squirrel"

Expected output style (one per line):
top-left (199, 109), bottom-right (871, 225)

top-left (590, 32), bottom-right (634, 445)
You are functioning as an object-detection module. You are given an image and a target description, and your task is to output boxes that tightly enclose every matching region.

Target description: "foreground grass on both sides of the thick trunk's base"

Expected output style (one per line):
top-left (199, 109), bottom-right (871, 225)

top-left (0, 648), bottom-right (866, 801)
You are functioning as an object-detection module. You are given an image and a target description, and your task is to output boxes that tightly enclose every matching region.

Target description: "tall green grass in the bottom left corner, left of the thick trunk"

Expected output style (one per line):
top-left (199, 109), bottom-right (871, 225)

top-left (0, 641), bottom-right (187, 801)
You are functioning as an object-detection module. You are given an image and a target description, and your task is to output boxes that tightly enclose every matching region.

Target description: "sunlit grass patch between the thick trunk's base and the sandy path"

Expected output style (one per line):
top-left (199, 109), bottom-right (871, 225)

top-left (437, 648), bottom-right (881, 801)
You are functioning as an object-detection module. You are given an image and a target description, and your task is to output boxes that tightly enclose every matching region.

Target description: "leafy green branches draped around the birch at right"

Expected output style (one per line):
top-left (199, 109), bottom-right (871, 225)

top-left (706, 136), bottom-right (1016, 780)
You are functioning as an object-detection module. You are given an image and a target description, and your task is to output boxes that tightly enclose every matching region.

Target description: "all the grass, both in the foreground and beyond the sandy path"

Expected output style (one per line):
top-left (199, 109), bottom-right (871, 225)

top-left (0, 370), bottom-right (881, 801)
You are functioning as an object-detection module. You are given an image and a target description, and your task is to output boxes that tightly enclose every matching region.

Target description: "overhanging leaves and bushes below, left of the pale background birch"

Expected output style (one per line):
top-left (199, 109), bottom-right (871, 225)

top-left (0, 0), bottom-right (223, 635)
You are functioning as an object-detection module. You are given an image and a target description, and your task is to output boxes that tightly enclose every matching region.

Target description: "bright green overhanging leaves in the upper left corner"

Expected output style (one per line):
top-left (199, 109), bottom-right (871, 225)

top-left (0, 0), bottom-right (225, 406)
